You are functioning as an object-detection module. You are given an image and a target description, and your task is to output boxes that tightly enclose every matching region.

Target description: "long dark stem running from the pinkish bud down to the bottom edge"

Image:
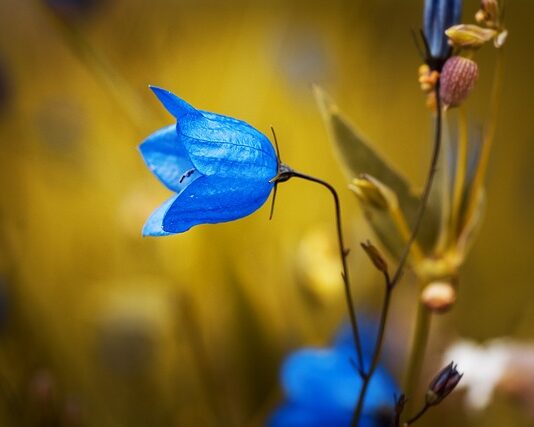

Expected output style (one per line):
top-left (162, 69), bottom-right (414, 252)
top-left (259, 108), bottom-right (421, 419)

top-left (351, 80), bottom-right (442, 427)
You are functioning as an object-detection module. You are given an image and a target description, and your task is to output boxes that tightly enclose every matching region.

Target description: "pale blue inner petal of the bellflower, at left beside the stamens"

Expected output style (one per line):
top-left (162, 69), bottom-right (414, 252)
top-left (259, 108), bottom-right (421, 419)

top-left (139, 126), bottom-right (201, 193)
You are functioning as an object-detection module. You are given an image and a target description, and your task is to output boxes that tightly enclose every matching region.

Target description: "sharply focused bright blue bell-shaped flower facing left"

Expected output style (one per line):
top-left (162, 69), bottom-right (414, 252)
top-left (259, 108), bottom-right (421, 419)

top-left (140, 87), bottom-right (278, 236)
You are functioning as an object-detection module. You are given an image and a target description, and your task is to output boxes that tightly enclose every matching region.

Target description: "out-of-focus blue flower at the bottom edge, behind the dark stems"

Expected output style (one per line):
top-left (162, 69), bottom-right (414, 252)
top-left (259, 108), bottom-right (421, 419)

top-left (267, 325), bottom-right (398, 427)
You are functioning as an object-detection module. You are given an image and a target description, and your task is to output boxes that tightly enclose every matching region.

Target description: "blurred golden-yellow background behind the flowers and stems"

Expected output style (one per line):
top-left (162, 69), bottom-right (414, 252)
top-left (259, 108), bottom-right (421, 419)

top-left (0, 0), bottom-right (534, 427)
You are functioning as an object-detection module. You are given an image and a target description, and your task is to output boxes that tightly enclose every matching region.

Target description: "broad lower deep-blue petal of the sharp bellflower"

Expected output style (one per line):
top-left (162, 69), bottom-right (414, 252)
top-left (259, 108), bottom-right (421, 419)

top-left (163, 176), bottom-right (273, 233)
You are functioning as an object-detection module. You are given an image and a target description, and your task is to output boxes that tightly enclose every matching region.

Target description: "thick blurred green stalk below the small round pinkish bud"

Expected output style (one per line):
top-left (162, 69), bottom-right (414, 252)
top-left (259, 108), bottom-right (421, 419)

top-left (404, 301), bottom-right (432, 414)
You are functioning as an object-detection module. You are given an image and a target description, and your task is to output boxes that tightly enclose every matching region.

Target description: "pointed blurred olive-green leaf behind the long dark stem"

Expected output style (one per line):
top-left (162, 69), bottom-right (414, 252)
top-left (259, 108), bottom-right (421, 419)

top-left (313, 86), bottom-right (439, 256)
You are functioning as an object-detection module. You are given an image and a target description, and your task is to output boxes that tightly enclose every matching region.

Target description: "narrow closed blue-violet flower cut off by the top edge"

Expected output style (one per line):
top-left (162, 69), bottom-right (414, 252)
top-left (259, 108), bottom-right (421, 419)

top-left (423, 0), bottom-right (462, 62)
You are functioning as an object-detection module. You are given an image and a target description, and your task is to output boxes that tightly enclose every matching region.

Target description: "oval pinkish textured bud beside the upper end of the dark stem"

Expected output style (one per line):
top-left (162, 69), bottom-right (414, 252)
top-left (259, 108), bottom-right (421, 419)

top-left (440, 56), bottom-right (478, 108)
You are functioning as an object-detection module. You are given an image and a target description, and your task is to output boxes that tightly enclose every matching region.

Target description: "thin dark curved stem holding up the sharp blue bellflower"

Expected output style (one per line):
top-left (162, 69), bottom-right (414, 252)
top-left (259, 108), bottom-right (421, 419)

top-left (284, 169), bottom-right (365, 375)
